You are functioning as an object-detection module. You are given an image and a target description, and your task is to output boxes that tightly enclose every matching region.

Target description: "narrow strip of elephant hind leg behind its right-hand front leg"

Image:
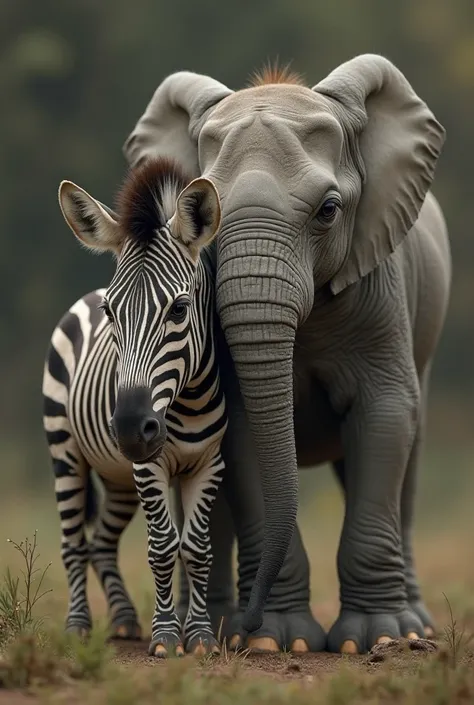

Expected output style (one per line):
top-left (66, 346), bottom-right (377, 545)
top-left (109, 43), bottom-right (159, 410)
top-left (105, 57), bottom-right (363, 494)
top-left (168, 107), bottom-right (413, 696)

top-left (400, 369), bottom-right (435, 638)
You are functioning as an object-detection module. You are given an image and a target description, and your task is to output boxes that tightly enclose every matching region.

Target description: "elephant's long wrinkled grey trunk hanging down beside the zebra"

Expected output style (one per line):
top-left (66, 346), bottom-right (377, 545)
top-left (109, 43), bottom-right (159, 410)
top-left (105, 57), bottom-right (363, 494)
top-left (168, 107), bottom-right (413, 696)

top-left (217, 234), bottom-right (298, 632)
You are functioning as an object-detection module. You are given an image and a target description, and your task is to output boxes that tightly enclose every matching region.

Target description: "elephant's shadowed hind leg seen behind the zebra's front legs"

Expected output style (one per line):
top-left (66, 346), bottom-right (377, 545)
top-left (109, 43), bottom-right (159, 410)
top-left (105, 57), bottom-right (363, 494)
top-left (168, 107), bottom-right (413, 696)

top-left (175, 478), bottom-right (235, 636)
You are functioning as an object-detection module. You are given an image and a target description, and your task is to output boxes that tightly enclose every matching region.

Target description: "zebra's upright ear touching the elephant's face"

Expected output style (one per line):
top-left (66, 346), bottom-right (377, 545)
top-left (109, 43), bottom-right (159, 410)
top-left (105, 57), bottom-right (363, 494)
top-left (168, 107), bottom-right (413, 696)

top-left (170, 178), bottom-right (221, 258)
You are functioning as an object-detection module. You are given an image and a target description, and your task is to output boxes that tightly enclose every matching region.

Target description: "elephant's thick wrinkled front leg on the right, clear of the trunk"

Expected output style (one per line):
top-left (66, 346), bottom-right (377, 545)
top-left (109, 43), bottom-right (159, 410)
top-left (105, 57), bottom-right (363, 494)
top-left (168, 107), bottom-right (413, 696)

top-left (328, 384), bottom-right (423, 653)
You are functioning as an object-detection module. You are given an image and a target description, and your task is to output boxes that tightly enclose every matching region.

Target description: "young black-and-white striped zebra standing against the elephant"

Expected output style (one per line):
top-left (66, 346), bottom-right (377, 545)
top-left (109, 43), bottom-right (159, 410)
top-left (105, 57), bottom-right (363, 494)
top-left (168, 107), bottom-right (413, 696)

top-left (43, 158), bottom-right (227, 658)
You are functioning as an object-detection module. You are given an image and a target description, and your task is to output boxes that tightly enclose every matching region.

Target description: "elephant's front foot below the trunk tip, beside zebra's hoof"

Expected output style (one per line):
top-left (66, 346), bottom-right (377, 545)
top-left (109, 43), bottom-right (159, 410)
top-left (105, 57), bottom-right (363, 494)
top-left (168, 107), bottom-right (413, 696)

top-left (229, 610), bottom-right (326, 654)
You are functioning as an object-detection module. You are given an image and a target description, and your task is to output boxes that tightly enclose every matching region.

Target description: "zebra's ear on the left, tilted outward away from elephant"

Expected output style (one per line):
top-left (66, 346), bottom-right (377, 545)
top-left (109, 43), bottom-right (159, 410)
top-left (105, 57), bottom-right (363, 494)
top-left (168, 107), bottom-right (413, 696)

top-left (58, 181), bottom-right (123, 254)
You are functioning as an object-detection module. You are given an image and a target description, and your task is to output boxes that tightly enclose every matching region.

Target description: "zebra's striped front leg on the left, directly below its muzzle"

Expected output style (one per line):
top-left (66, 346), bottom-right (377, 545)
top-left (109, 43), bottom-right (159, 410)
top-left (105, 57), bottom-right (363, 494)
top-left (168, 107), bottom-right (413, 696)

top-left (133, 464), bottom-right (184, 658)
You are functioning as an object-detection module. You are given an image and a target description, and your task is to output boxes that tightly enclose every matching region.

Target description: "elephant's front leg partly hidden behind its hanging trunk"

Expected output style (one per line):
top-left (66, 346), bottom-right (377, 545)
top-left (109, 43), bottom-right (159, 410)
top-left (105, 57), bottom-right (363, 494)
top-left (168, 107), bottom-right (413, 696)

top-left (218, 344), bottom-right (326, 652)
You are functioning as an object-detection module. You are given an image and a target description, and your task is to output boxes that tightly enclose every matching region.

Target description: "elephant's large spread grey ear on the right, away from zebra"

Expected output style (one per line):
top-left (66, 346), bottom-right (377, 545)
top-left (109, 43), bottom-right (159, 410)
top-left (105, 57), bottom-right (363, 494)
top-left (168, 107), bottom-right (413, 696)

top-left (313, 54), bottom-right (445, 294)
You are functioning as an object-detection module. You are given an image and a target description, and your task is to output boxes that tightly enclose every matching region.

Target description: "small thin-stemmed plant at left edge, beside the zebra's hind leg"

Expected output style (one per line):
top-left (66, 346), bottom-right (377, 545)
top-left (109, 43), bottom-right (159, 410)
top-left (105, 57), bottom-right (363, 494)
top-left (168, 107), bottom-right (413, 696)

top-left (0, 531), bottom-right (51, 643)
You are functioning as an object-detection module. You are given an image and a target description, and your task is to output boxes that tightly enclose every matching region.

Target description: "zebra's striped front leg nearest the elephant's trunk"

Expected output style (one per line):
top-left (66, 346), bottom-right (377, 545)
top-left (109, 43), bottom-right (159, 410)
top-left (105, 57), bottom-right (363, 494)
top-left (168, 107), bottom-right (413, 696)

top-left (180, 452), bottom-right (224, 656)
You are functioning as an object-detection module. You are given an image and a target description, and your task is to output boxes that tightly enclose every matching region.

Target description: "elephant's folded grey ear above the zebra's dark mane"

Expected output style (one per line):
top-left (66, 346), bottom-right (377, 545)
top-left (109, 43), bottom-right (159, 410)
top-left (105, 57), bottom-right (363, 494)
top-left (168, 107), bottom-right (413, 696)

top-left (123, 71), bottom-right (232, 177)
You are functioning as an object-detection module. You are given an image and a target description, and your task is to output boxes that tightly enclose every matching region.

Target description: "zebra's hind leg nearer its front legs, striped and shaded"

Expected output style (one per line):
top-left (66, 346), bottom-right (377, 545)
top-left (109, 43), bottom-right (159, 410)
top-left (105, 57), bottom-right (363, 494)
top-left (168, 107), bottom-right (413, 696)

top-left (90, 481), bottom-right (141, 639)
